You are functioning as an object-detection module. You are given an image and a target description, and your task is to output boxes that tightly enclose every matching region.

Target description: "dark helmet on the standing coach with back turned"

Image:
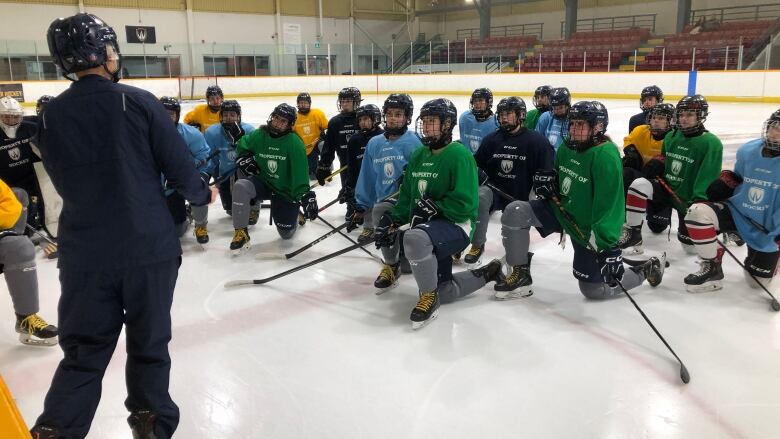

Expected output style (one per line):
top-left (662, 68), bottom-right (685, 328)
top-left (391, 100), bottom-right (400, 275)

top-left (46, 13), bottom-right (122, 82)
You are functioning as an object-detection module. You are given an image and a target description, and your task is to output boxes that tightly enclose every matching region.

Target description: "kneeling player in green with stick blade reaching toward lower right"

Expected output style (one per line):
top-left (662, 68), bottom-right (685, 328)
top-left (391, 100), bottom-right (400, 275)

top-left (495, 101), bottom-right (666, 300)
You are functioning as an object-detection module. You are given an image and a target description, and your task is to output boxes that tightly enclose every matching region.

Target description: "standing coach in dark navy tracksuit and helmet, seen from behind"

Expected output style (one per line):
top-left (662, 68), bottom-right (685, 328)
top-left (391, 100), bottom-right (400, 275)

top-left (32, 14), bottom-right (214, 438)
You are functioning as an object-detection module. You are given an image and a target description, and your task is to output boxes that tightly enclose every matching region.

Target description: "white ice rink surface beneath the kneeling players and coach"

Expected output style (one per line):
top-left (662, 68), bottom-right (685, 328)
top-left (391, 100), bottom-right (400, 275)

top-left (0, 93), bottom-right (780, 439)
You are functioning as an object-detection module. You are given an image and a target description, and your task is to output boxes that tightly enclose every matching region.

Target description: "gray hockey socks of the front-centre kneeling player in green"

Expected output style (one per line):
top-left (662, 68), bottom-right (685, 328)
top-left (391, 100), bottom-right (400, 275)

top-left (404, 229), bottom-right (485, 303)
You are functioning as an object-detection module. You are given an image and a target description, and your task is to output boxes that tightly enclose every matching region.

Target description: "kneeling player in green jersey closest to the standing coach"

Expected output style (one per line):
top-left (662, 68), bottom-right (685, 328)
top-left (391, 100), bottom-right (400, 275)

top-left (230, 104), bottom-right (317, 253)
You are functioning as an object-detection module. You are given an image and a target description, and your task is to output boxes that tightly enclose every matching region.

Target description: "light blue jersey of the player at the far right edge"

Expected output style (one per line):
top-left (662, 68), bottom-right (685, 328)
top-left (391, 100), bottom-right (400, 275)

top-left (729, 139), bottom-right (780, 253)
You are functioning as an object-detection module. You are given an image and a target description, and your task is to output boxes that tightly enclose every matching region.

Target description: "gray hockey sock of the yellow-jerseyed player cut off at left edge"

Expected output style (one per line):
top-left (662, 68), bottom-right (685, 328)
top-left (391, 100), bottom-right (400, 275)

top-left (0, 188), bottom-right (38, 316)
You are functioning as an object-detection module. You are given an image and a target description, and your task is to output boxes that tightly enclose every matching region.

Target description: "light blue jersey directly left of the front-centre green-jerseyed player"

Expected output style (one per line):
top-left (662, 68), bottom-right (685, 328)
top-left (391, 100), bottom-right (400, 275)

top-left (355, 130), bottom-right (422, 209)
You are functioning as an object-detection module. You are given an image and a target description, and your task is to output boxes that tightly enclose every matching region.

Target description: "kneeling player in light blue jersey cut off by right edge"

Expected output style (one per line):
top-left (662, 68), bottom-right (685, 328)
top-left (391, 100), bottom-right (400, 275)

top-left (684, 110), bottom-right (780, 292)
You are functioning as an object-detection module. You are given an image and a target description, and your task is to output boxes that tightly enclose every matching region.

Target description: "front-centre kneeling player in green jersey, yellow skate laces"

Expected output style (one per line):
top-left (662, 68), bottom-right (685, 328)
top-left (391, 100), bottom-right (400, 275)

top-left (374, 99), bottom-right (502, 329)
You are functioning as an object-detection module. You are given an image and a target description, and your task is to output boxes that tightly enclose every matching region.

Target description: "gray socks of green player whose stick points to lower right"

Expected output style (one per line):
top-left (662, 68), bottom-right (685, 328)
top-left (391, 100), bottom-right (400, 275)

top-left (501, 201), bottom-right (645, 300)
